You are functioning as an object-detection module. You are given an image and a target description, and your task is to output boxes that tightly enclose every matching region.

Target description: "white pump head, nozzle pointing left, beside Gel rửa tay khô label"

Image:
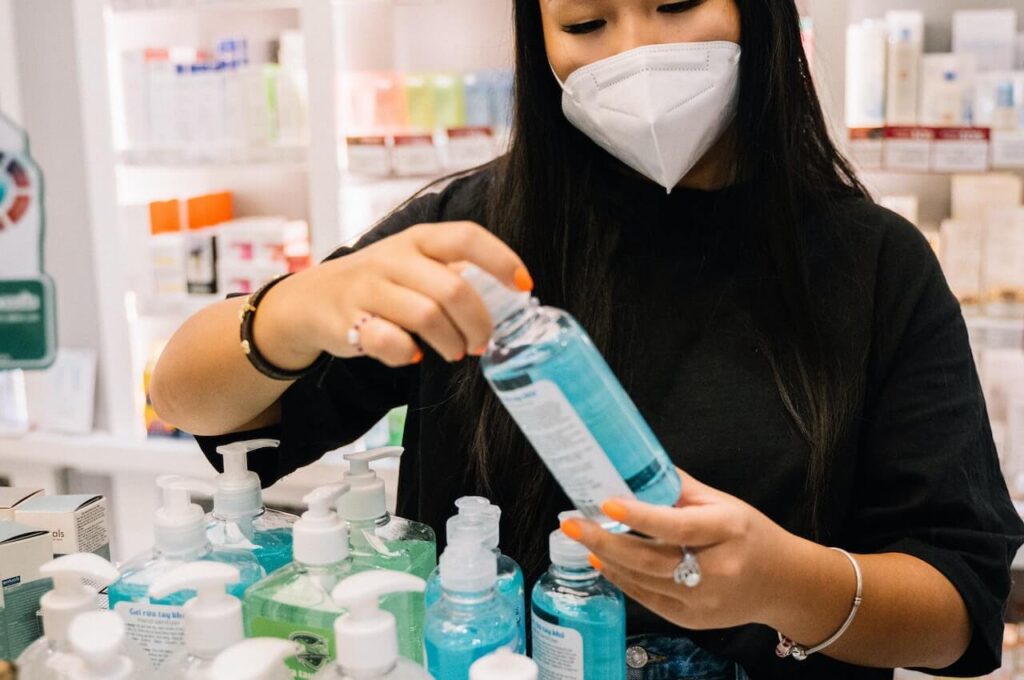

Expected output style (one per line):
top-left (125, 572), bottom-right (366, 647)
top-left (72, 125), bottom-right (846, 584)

top-left (150, 561), bottom-right (245, 658)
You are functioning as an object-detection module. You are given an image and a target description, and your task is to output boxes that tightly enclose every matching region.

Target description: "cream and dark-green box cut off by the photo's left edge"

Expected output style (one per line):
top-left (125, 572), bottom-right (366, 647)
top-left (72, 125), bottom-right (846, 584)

top-left (0, 521), bottom-right (53, 658)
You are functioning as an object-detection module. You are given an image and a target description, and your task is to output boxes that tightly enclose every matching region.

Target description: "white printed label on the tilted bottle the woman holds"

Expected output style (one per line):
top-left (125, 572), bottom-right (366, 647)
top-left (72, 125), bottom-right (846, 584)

top-left (495, 380), bottom-right (633, 518)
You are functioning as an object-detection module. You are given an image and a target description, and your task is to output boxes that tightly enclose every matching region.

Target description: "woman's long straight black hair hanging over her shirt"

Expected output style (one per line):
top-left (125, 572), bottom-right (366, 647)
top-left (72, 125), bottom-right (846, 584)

top-left (438, 0), bottom-right (866, 573)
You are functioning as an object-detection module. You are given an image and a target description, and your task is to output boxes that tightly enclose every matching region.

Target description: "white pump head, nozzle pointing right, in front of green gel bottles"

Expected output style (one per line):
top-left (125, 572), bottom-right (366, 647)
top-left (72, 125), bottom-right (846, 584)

top-left (331, 569), bottom-right (427, 678)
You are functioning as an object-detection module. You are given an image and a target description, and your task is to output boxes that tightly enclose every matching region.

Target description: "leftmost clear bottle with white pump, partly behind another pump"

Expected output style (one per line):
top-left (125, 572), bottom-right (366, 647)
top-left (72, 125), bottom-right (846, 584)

top-left (17, 553), bottom-right (150, 680)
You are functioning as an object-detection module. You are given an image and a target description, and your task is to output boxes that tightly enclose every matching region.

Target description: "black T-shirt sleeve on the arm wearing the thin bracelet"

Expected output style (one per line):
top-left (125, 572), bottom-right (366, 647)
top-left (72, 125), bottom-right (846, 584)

top-left (844, 217), bottom-right (1024, 676)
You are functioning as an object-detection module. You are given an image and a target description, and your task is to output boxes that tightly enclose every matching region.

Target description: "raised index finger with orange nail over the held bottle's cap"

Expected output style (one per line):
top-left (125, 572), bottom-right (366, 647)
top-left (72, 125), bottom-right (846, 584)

top-left (408, 222), bottom-right (534, 291)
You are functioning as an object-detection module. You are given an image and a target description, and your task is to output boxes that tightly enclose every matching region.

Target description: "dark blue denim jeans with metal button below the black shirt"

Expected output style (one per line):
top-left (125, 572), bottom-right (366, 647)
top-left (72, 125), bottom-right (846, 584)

top-left (626, 635), bottom-right (749, 680)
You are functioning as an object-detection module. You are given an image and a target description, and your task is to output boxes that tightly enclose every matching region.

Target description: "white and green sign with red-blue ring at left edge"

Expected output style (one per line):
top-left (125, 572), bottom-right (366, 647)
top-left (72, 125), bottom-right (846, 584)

top-left (0, 114), bottom-right (56, 371)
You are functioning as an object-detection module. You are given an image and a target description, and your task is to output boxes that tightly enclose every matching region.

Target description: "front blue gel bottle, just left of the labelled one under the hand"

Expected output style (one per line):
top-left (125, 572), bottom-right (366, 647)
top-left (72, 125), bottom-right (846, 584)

top-left (425, 522), bottom-right (519, 680)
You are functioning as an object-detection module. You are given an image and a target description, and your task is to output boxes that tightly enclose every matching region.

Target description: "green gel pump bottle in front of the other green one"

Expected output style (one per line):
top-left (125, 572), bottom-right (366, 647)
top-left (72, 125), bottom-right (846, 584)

top-left (243, 483), bottom-right (354, 680)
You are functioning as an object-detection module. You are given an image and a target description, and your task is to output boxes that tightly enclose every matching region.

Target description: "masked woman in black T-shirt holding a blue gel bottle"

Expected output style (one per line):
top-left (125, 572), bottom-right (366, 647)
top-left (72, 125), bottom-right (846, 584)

top-left (153, 0), bottom-right (1022, 679)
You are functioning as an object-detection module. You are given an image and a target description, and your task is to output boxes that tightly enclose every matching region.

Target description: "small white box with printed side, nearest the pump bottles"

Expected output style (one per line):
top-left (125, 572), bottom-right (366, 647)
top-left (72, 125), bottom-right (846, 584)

top-left (14, 494), bottom-right (111, 559)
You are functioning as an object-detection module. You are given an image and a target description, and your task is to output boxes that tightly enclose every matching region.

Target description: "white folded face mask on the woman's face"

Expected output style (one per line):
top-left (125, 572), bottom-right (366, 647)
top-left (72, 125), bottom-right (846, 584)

top-left (555, 42), bottom-right (740, 192)
